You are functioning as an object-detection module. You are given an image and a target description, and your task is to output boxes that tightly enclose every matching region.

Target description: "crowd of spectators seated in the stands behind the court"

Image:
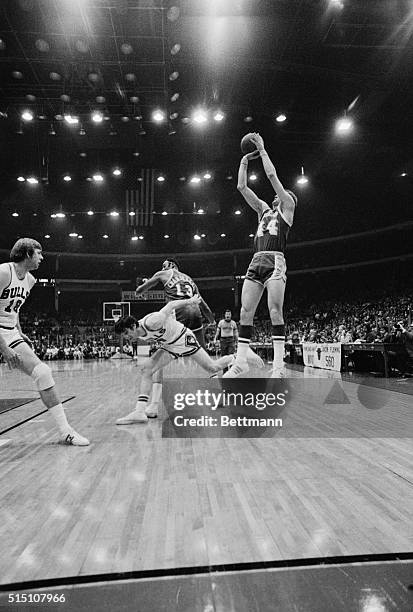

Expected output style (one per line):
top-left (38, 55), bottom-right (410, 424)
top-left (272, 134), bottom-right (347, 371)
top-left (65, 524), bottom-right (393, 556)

top-left (1, 295), bottom-right (413, 370)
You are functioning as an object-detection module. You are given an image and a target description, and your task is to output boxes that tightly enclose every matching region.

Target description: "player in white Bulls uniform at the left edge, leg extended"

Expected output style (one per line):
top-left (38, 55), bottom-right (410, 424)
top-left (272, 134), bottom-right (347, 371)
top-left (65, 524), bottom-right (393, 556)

top-left (0, 238), bottom-right (89, 446)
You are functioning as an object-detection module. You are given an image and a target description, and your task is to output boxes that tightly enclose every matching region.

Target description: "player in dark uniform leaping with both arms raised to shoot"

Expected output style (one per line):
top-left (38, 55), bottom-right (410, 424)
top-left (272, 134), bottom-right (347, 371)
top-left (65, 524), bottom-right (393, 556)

top-left (224, 134), bottom-right (297, 378)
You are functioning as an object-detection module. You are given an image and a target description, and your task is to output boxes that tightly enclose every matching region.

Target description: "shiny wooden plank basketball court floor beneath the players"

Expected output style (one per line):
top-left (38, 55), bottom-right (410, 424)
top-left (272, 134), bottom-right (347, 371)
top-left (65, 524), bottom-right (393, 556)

top-left (0, 360), bottom-right (413, 584)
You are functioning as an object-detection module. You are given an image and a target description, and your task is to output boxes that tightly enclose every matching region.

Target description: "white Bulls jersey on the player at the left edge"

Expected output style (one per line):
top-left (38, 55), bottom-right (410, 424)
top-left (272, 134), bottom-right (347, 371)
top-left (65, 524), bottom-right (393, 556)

top-left (0, 263), bottom-right (35, 329)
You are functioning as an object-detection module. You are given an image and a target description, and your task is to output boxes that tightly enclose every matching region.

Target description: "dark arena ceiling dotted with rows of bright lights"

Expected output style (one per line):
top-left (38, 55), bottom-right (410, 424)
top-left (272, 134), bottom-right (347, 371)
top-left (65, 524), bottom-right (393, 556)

top-left (0, 0), bottom-right (413, 252)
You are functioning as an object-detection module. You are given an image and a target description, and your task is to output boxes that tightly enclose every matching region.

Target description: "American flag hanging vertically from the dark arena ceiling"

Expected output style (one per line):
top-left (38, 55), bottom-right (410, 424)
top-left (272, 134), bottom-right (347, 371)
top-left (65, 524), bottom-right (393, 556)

top-left (125, 168), bottom-right (155, 227)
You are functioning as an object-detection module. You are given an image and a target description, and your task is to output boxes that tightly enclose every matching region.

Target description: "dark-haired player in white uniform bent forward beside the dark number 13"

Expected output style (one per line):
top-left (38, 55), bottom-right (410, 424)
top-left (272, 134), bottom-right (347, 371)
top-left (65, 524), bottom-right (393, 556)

top-left (115, 296), bottom-right (233, 425)
